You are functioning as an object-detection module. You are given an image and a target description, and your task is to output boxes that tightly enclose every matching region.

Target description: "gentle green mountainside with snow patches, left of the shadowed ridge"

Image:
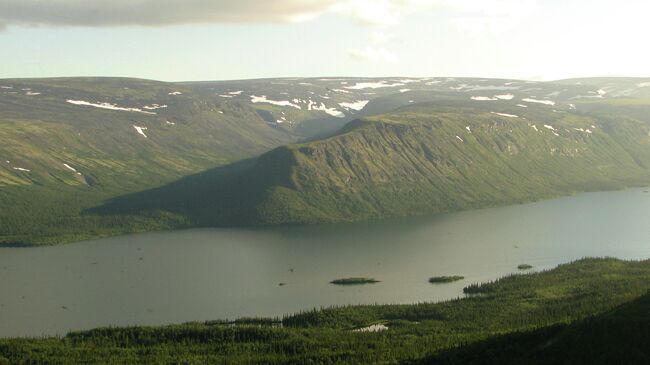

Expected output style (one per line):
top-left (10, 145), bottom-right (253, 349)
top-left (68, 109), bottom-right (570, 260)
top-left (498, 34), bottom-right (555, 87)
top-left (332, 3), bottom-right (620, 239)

top-left (0, 78), bottom-right (296, 244)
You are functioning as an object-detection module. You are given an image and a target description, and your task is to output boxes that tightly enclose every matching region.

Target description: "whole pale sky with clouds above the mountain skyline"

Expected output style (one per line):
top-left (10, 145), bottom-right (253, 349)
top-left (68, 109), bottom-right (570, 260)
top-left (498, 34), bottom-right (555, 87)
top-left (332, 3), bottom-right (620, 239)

top-left (0, 0), bottom-right (650, 81)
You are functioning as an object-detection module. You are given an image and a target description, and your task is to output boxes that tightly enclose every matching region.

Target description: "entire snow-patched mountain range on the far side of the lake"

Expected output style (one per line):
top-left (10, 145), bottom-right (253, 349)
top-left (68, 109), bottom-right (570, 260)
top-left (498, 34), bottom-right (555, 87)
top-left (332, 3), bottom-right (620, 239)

top-left (0, 78), bottom-right (650, 245)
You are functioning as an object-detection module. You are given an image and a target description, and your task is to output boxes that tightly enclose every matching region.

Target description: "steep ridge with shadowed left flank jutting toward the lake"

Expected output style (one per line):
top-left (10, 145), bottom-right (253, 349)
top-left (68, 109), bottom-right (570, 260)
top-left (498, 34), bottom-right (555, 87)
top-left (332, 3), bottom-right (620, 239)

top-left (104, 96), bottom-right (650, 226)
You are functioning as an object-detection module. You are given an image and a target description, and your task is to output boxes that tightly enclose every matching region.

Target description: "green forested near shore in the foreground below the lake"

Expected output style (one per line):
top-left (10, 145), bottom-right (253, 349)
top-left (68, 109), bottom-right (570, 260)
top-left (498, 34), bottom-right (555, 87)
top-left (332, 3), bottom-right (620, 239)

top-left (0, 259), bottom-right (650, 364)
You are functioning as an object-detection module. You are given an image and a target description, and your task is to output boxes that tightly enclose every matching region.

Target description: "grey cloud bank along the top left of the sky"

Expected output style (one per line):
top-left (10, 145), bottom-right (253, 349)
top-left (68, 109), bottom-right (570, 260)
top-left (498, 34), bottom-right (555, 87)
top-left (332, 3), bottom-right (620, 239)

top-left (0, 0), bottom-right (426, 26)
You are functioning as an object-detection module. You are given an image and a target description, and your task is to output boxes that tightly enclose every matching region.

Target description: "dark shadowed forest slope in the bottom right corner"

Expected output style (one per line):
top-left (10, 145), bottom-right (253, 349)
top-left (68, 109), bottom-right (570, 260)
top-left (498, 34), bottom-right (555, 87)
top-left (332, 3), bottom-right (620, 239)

top-left (415, 294), bottom-right (650, 365)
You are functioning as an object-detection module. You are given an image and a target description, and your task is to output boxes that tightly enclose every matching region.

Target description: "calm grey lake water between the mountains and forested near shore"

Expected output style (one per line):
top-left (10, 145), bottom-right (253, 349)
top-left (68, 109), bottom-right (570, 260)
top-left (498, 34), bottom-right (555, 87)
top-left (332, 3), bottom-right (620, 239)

top-left (0, 189), bottom-right (650, 337)
